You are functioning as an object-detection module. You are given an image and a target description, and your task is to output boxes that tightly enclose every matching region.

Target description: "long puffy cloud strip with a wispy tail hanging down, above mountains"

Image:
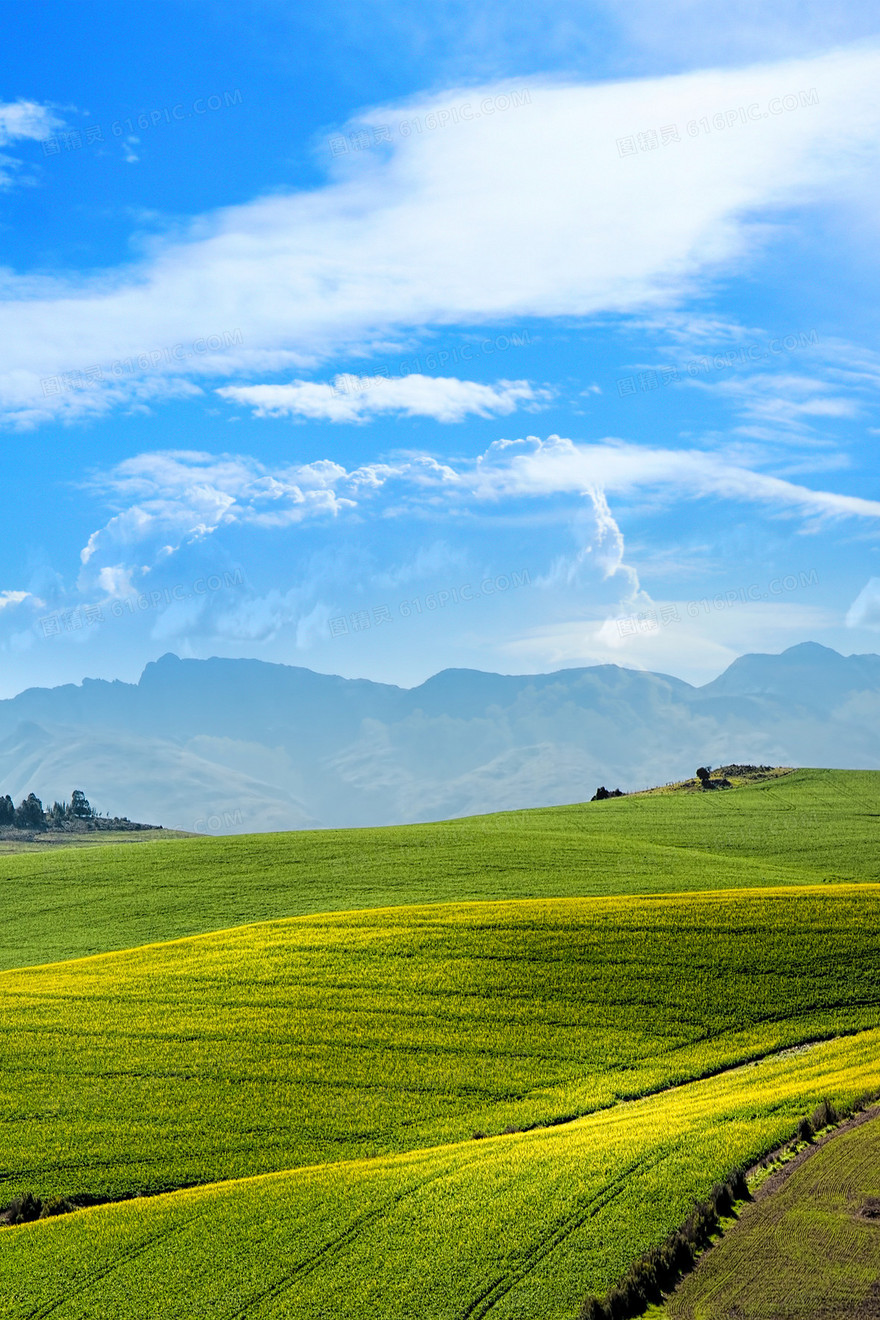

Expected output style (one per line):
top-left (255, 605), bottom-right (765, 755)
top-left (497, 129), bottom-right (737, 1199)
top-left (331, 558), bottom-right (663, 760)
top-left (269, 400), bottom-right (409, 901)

top-left (73, 436), bottom-right (880, 601)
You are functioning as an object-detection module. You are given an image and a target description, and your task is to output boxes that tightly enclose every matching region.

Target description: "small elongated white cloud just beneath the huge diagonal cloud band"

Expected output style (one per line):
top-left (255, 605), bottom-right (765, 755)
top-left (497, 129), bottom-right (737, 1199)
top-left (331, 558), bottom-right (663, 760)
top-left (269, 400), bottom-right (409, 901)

top-left (216, 375), bottom-right (549, 422)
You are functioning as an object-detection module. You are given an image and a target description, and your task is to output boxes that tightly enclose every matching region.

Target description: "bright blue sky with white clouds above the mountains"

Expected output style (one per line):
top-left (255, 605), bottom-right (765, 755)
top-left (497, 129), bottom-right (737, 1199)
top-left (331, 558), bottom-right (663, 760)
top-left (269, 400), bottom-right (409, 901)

top-left (0, 0), bottom-right (880, 697)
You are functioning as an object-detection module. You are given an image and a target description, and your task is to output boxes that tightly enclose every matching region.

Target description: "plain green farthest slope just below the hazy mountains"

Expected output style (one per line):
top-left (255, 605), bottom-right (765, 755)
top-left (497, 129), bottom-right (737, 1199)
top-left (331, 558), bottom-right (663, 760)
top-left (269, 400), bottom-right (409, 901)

top-left (0, 771), bottom-right (880, 968)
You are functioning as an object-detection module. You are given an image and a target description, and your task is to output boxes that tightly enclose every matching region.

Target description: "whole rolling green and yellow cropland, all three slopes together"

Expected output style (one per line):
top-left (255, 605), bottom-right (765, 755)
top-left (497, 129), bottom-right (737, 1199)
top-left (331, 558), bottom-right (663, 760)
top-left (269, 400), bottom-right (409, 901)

top-left (0, 771), bottom-right (880, 1320)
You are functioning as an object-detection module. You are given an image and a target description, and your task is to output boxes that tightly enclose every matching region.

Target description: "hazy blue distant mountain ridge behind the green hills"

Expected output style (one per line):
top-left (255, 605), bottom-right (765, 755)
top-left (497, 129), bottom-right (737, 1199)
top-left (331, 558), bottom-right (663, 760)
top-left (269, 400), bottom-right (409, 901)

top-left (0, 642), bottom-right (880, 833)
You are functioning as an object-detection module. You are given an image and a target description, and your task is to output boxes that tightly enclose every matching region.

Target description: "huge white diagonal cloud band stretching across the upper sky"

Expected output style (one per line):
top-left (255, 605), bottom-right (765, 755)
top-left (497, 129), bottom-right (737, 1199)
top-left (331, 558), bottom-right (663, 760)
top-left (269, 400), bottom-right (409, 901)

top-left (0, 48), bottom-right (880, 422)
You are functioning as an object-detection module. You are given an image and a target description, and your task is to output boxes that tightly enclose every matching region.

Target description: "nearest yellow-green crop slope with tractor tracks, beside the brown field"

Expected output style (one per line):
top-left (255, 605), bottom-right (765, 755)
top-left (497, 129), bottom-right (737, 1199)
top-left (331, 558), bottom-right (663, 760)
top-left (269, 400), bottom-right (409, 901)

top-left (0, 1032), bottom-right (880, 1320)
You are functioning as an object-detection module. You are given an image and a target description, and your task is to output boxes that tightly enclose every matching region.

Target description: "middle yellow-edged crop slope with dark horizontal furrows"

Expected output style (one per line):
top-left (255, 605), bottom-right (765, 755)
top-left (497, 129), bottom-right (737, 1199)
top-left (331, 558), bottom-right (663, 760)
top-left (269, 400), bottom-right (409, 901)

top-left (0, 886), bottom-right (880, 1199)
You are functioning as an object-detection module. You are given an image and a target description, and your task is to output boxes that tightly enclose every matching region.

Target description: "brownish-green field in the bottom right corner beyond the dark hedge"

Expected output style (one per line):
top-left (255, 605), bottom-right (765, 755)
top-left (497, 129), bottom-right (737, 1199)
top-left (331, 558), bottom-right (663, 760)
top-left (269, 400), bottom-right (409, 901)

top-left (666, 1118), bottom-right (880, 1320)
